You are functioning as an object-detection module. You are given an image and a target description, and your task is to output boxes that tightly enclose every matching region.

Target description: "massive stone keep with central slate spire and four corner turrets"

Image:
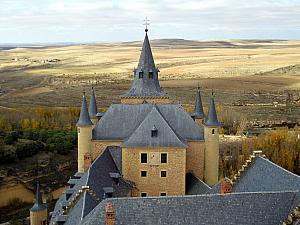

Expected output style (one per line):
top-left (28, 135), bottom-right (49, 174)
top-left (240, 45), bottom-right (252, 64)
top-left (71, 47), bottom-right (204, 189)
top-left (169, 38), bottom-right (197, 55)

top-left (77, 28), bottom-right (220, 196)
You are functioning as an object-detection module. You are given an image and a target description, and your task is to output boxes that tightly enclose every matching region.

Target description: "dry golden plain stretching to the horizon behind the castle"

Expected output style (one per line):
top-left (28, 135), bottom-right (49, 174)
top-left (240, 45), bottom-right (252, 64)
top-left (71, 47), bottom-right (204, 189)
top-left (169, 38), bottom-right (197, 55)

top-left (0, 39), bottom-right (300, 123)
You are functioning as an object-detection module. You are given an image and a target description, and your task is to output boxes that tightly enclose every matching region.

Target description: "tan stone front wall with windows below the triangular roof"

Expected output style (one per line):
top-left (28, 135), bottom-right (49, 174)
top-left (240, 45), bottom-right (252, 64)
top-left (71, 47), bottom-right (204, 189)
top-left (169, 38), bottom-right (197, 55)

top-left (122, 148), bottom-right (186, 196)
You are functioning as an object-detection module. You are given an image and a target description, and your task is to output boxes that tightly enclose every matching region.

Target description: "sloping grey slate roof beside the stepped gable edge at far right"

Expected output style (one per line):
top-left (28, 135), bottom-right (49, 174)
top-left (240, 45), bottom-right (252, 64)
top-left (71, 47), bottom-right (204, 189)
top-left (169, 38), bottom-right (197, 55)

top-left (233, 157), bottom-right (300, 203)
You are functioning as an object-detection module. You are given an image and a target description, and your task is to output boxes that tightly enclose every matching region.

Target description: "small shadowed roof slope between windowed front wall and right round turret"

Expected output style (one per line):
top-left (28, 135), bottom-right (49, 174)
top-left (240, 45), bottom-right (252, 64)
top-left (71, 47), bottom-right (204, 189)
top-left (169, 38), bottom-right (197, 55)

top-left (186, 173), bottom-right (211, 195)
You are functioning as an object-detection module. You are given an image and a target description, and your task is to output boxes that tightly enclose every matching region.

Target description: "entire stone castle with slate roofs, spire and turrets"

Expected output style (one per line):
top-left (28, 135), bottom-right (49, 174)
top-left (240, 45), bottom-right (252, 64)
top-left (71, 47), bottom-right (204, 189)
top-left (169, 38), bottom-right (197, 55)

top-left (31, 30), bottom-right (300, 225)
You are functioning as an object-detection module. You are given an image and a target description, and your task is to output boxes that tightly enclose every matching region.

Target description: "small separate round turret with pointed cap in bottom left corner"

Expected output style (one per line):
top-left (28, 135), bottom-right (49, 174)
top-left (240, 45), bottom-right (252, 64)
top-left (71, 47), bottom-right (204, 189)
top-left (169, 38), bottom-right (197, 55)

top-left (30, 182), bottom-right (48, 225)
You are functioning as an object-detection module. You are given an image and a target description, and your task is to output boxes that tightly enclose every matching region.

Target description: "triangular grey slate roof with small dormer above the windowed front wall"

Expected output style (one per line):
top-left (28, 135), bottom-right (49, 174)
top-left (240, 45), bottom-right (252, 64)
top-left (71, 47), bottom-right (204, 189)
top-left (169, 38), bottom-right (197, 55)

top-left (122, 105), bottom-right (187, 148)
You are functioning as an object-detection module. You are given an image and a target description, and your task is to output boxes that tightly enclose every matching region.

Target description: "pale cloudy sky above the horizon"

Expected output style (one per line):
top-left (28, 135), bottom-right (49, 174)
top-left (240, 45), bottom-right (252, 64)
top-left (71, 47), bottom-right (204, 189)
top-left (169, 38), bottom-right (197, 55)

top-left (0, 0), bottom-right (300, 44)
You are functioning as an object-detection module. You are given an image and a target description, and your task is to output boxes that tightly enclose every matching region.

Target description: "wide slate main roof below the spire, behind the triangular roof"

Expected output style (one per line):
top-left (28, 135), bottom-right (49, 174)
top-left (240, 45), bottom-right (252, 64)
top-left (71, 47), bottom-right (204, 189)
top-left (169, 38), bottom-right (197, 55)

top-left (93, 104), bottom-right (204, 141)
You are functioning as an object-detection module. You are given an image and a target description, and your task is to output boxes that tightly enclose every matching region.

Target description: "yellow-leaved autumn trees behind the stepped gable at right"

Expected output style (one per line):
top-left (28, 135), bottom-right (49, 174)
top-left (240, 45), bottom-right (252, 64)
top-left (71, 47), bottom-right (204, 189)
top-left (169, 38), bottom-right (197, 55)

top-left (220, 128), bottom-right (300, 177)
